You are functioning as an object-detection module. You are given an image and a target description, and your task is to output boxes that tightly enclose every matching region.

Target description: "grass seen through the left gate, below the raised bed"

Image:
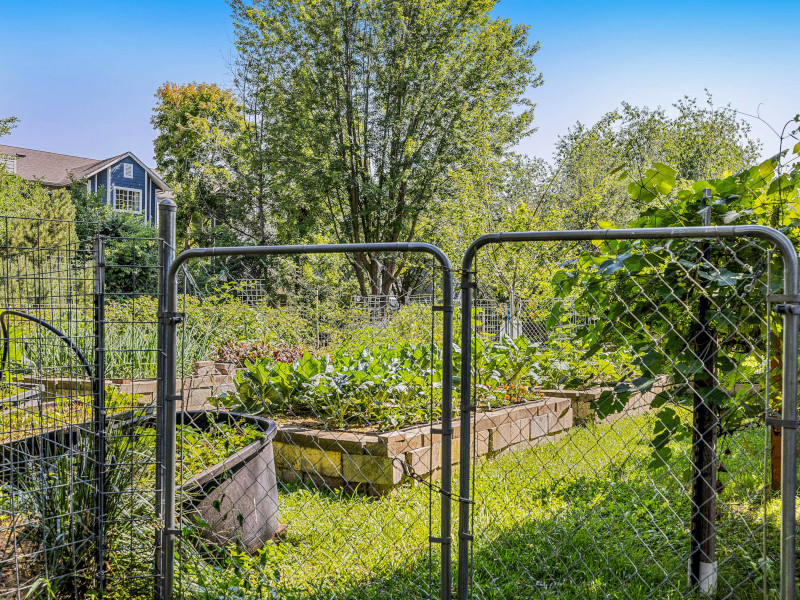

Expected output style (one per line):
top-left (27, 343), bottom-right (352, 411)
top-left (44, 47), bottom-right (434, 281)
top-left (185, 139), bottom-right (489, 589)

top-left (179, 484), bottom-right (450, 600)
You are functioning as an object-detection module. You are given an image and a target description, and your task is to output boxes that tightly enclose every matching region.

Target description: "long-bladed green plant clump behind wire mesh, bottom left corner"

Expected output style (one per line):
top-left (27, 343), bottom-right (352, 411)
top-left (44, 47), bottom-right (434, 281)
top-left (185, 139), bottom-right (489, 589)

top-left (7, 425), bottom-right (155, 598)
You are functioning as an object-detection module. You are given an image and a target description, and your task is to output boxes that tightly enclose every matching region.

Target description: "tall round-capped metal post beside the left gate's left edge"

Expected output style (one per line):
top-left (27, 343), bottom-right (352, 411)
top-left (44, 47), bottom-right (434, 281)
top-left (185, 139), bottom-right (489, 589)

top-left (155, 196), bottom-right (177, 598)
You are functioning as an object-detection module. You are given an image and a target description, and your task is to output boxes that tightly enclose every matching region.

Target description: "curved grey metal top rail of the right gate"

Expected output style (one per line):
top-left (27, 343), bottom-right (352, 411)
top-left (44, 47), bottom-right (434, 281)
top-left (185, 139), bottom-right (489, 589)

top-left (462, 225), bottom-right (798, 294)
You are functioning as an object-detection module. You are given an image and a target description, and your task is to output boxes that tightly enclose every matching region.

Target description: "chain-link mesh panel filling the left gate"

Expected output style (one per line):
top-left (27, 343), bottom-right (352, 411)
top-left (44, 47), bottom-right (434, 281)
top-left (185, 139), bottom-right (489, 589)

top-left (162, 247), bottom-right (452, 599)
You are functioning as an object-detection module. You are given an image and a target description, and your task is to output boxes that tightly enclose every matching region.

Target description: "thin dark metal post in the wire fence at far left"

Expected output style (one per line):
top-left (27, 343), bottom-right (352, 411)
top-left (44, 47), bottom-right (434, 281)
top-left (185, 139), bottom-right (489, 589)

top-left (92, 236), bottom-right (106, 596)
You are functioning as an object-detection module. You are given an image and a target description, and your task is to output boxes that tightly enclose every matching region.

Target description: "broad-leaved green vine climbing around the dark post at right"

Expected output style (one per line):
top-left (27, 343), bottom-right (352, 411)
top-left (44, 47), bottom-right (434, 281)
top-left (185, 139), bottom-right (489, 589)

top-left (549, 150), bottom-right (800, 464)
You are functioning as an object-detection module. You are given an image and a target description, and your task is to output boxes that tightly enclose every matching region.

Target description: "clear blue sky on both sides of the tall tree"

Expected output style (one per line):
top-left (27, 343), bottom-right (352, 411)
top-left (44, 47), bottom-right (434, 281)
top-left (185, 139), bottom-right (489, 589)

top-left (0, 0), bottom-right (800, 163)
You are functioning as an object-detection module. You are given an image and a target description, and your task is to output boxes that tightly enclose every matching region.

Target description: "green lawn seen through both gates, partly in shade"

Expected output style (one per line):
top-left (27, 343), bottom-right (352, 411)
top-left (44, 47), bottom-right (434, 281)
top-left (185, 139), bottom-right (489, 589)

top-left (175, 415), bottom-right (779, 600)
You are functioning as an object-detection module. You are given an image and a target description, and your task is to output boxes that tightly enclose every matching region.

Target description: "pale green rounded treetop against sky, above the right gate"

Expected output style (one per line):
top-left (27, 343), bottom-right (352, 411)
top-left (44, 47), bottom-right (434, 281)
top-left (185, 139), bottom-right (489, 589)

top-left (551, 95), bottom-right (760, 229)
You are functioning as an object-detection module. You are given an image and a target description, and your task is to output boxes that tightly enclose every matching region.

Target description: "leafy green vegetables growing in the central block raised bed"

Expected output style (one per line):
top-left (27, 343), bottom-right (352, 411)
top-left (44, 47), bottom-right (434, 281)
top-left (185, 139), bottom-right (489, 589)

top-left (215, 338), bottom-right (633, 429)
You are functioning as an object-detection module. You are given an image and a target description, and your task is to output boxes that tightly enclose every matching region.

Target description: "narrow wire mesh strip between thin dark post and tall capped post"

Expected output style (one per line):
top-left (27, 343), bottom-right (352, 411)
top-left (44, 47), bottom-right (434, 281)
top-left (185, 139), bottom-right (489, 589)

top-left (99, 237), bottom-right (161, 598)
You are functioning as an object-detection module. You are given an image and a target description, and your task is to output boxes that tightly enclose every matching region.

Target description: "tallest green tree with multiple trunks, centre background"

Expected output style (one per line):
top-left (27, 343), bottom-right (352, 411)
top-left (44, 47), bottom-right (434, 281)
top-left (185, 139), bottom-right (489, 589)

top-left (230, 0), bottom-right (541, 294)
